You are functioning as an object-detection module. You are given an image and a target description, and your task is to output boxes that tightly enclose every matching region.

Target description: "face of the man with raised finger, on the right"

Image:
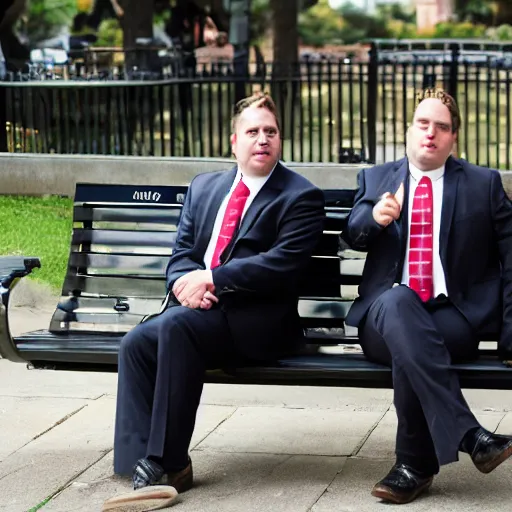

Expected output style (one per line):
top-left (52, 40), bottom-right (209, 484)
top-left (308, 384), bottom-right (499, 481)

top-left (407, 98), bottom-right (457, 171)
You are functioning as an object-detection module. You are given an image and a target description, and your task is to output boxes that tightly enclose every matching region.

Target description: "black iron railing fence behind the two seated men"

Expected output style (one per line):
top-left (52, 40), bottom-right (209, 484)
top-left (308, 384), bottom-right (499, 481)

top-left (0, 41), bottom-right (512, 169)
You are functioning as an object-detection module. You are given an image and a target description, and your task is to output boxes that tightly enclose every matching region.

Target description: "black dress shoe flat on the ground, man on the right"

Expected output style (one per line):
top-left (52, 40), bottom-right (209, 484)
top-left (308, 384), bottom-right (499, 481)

top-left (372, 464), bottom-right (434, 505)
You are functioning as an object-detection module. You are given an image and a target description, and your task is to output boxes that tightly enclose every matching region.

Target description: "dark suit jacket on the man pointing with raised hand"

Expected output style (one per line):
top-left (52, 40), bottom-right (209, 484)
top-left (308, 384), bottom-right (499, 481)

top-left (342, 157), bottom-right (512, 356)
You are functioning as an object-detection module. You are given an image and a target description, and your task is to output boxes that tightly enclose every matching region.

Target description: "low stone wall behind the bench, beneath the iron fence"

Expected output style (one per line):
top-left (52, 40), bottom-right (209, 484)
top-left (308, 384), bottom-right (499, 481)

top-left (0, 153), bottom-right (512, 197)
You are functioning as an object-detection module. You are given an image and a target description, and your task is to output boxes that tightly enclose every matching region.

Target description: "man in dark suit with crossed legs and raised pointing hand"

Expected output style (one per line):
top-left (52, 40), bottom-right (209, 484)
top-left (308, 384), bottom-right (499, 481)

top-left (343, 90), bottom-right (512, 503)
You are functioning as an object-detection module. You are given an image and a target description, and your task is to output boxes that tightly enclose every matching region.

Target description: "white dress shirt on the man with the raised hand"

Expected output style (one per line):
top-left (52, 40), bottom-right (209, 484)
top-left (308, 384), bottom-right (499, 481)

top-left (402, 162), bottom-right (448, 297)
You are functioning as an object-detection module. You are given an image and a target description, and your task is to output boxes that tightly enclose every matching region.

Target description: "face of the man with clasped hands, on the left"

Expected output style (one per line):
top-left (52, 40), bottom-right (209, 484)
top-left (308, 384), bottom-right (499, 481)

top-left (231, 107), bottom-right (281, 176)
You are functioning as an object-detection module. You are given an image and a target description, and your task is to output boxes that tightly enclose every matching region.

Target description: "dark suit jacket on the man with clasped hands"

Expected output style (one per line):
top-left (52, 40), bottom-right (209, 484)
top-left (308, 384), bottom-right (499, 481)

top-left (167, 164), bottom-right (325, 359)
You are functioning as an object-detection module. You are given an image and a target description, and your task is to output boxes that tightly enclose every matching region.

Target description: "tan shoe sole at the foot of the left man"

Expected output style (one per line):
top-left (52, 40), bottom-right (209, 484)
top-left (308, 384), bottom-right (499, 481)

top-left (102, 485), bottom-right (178, 512)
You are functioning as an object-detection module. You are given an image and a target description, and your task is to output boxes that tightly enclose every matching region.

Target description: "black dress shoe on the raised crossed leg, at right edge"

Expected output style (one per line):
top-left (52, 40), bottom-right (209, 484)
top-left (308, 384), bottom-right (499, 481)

top-left (470, 428), bottom-right (512, 473)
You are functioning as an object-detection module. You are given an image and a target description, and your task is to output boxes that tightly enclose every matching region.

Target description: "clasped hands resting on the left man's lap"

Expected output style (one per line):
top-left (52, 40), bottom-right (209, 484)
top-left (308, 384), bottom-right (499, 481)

top-left (172, 270), bottom-right (218, 309)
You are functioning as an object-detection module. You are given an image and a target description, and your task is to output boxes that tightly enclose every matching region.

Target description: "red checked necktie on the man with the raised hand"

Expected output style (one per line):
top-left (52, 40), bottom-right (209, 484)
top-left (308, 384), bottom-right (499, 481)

top-left (409, 176), bottom-right (434, 302)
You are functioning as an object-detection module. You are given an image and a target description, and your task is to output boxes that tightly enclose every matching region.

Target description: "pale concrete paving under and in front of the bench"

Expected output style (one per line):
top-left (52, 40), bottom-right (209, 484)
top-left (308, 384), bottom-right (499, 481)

top-left (0, 307), bottom-right (512, 512)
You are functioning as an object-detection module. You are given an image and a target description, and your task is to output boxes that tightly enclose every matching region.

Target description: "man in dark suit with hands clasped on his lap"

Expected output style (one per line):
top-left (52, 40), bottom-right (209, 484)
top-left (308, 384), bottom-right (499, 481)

top-left (104, 94), bottom-right (324, 511)
